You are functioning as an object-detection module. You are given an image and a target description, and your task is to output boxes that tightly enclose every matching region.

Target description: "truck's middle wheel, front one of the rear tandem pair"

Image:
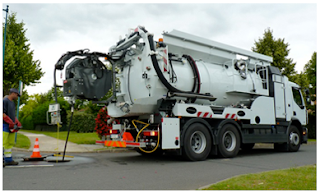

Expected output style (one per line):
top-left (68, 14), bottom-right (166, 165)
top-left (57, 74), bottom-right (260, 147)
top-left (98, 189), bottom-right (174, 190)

top-left (218, 124), bottom-right (240, 158)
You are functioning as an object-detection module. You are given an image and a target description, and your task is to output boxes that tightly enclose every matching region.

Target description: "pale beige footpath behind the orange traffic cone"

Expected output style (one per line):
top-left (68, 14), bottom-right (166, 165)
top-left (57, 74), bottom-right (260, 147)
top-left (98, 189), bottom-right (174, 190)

top-left (13, 131), bottom-right (111, 153)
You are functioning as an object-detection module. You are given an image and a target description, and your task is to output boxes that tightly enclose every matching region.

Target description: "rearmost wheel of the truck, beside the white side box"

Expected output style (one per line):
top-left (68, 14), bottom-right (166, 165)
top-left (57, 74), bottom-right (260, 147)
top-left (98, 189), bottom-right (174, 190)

top-left (182, 123), bottom-right (212, 161)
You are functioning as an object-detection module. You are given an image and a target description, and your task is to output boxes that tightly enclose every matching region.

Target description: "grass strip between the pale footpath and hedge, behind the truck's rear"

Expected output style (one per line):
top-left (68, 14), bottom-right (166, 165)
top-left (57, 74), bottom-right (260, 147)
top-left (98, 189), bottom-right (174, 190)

top-left (22, 130), bottom-right (100, 144)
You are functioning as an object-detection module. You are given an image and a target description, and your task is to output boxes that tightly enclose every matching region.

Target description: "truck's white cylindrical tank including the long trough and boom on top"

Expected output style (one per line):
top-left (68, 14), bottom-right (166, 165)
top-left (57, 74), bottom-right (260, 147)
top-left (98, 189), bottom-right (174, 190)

top-left (108, 28), bottom-right (272, 117)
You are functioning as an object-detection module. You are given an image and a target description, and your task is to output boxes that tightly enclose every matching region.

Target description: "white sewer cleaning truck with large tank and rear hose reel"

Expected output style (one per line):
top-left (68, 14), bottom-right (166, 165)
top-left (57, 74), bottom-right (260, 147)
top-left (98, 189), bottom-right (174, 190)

top-left (55, 26), bottom-right (308, 161)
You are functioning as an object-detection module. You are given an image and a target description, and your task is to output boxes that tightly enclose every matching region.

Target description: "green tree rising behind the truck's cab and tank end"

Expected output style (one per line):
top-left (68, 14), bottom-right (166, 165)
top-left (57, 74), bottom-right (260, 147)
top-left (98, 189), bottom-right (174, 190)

top-left (252, 28), bottom-right (296, 80)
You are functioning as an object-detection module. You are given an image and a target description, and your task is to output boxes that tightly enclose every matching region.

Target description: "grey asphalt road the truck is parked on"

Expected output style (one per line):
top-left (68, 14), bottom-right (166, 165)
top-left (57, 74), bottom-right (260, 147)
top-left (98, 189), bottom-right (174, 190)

top-left (3, 144), bottom-right (316, 190)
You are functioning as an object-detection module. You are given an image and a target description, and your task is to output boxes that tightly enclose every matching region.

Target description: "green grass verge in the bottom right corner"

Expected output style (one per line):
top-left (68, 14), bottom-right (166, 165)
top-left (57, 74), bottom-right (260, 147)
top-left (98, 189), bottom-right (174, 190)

top-left (204, 165), bottom-right (317, 190)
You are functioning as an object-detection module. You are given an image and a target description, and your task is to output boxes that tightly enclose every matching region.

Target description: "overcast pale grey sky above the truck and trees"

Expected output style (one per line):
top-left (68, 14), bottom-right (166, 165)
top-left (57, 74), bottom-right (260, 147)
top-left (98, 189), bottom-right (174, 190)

top-left (2, 3), bottom-right (317, 95)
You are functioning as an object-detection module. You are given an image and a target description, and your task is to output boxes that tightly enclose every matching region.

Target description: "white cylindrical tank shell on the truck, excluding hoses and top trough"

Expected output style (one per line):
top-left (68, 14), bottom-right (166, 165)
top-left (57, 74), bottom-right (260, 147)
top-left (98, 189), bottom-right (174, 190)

top-left (108, 48), bottom-right (268, 117)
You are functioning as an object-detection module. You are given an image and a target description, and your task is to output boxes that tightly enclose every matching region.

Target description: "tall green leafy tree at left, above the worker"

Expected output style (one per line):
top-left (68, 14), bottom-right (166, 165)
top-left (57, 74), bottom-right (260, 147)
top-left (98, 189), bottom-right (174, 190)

top-left (3, 13), bottom-right (44, 98)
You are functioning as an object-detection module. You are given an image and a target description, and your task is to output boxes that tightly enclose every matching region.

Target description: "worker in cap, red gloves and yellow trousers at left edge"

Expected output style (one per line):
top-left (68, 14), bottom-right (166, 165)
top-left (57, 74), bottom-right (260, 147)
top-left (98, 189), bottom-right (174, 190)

top-left (2, 88), bottom-right (22, 165)
